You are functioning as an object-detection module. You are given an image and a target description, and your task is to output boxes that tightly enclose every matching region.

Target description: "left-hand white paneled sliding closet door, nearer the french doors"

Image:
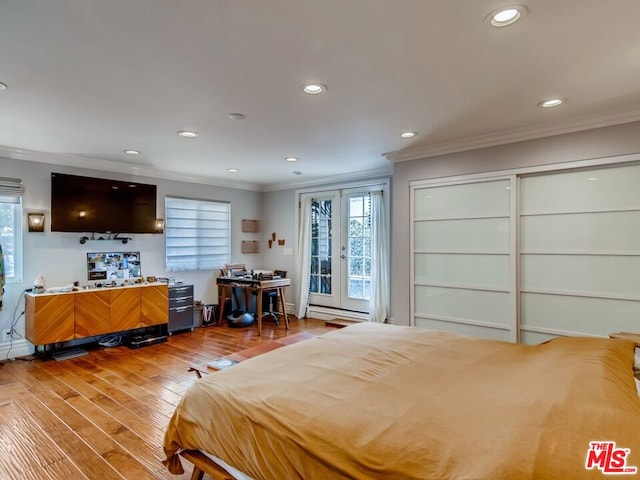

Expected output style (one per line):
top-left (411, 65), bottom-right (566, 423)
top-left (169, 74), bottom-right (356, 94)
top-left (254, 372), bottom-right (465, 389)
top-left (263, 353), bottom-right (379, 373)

top-left (411, 177), bottom-right (517, 341)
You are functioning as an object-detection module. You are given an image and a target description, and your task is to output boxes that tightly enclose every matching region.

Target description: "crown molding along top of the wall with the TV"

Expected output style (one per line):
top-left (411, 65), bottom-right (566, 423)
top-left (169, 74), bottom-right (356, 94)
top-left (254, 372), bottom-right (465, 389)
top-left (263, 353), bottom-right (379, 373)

top-left (0, 145), bottom-right (262, 191)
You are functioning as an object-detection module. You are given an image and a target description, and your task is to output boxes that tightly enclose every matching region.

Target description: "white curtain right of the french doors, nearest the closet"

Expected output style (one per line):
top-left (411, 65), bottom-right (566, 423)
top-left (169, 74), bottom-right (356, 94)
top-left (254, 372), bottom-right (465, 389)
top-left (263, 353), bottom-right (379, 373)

top-left (369, 190), bottom-right (390, 323)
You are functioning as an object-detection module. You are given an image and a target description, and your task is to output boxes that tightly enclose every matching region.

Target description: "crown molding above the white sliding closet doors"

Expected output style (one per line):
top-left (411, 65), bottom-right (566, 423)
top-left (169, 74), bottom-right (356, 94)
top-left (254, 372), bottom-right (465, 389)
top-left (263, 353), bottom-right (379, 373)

top-left (382, 109), bottom-right (640, 163)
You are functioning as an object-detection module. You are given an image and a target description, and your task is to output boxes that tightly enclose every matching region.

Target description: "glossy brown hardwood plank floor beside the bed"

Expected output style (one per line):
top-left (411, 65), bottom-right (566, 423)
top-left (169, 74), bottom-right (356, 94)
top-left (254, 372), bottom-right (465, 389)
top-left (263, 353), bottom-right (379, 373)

top-left (0, 316), bottom-right (333, 480)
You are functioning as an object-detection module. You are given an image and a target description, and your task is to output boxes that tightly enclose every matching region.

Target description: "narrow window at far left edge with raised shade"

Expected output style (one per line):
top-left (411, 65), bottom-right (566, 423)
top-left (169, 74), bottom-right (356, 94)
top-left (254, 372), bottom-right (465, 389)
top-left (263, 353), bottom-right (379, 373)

top-left (0, 177), bottom-right (23, 283)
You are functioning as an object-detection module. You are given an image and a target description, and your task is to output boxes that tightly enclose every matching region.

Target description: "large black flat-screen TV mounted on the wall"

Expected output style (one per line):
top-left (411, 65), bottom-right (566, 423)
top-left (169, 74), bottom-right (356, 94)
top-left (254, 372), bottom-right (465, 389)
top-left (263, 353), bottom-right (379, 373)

top-left (51, 173), bottom-right (156, 233)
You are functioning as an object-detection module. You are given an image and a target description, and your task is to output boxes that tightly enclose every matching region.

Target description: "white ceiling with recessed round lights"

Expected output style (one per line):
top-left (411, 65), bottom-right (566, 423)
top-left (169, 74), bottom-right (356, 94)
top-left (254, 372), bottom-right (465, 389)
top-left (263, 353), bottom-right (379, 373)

top-left (0, 0), bottom-right (640, 190)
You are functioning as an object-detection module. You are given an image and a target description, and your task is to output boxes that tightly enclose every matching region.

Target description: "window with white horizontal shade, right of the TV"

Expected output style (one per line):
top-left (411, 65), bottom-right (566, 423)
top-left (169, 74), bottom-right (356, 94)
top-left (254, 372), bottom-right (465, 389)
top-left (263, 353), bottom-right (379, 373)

top-left (165, 197), bottom-right (231, 272)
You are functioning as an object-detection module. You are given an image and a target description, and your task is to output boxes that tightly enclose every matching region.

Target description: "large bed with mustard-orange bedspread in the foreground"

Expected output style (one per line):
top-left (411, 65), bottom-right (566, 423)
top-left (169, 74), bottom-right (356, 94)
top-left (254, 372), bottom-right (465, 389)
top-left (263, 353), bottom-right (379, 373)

top-left (164, 323), bottom-right (640, 480)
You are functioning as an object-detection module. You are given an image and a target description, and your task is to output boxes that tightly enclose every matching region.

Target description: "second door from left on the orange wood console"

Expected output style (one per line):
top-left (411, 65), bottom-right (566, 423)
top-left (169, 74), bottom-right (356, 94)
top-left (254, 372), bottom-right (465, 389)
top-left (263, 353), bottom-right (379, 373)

top-left (74, 290), bottom-right (113, 338)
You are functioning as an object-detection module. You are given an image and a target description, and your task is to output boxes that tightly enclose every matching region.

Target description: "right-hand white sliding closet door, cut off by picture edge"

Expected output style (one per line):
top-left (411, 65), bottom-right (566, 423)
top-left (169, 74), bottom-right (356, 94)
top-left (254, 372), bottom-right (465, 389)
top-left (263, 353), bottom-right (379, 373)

top-left (520, 165), bottom-right (640, 343)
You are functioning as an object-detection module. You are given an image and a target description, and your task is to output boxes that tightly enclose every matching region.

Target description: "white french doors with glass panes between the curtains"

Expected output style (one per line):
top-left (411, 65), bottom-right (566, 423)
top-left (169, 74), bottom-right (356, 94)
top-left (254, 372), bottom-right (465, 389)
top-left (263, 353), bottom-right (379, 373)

top-left (309, 189), bottom-right (371, 312)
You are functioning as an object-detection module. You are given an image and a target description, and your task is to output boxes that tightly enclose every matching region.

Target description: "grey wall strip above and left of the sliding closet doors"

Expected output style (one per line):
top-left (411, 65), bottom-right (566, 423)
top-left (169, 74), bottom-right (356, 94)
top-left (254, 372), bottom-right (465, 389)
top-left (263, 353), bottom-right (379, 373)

top-left (391, 122), bottom-right (640, 325)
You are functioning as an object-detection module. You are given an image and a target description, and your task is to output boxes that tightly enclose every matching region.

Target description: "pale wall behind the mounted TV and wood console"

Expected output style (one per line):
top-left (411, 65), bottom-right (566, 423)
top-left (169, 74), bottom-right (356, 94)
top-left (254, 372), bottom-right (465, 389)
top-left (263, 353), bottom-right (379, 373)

top-left (0, 157), bottom-right (262, 354)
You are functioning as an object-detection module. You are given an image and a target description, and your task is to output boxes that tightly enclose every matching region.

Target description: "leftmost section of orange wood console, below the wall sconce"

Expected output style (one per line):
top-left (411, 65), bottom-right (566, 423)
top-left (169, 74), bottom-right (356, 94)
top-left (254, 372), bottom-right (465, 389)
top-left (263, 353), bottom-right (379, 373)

top-left (25, 294), bottom-right (75, 345)
